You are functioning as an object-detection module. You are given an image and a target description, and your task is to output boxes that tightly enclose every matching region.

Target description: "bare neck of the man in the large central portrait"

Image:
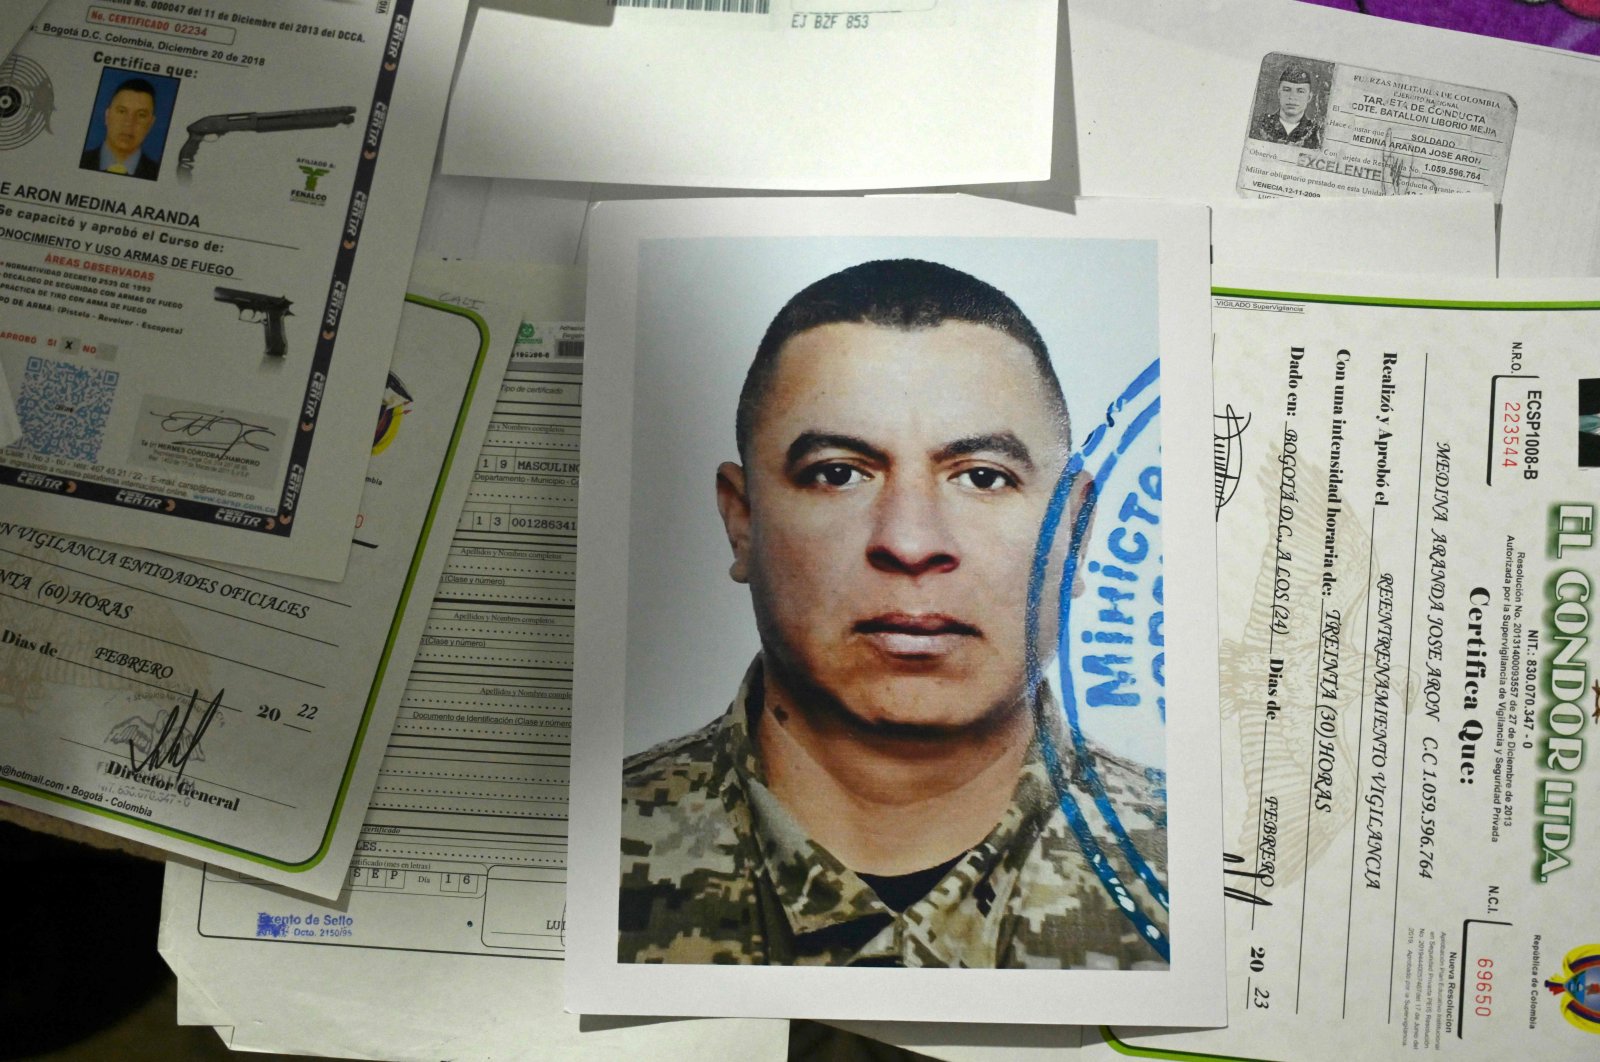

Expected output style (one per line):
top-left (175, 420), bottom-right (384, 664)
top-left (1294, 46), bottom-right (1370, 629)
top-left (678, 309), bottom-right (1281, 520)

top-left (752, 677), bottom-right (1030, 875)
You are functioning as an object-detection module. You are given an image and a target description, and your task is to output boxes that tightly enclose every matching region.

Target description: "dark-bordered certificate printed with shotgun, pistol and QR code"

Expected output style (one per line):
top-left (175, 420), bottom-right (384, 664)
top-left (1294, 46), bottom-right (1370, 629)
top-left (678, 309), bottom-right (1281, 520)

top-left (0, 0), bottom-right (466, 579)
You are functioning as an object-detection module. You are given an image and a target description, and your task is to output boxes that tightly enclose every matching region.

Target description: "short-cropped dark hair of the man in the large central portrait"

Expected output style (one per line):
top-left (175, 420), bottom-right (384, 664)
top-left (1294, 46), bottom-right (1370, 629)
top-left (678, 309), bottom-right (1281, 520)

top-left (734, 258), bottom-right (1069, 461)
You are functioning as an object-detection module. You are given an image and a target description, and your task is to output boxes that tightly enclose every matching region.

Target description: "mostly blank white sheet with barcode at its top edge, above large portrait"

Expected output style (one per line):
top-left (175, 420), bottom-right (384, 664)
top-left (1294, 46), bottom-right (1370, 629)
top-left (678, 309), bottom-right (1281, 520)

top-left (443, 0), bottom-right (1056, 190)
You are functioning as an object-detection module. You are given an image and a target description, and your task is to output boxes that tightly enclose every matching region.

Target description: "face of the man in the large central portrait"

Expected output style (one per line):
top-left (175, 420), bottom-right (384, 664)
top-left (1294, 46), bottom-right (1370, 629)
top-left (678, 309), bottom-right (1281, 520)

top-left (718, 321), bottom-right (1069, 731)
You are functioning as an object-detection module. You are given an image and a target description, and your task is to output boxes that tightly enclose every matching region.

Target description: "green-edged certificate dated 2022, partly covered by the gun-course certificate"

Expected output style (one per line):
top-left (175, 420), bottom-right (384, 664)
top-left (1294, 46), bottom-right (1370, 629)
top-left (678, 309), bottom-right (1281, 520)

top-left (0, 291), bottom-right (517, 896)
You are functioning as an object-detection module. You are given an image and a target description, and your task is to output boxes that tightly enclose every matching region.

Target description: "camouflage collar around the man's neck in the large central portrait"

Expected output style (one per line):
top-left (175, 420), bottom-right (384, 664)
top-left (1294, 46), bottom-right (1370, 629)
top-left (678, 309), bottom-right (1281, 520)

top-left (715, 657), bottom-right (1061, 968)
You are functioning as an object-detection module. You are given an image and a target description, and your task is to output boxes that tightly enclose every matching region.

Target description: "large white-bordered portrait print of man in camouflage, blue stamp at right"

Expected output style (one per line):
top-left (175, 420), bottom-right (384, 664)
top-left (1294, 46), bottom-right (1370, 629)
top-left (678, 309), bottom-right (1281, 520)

top-left (566, 197), bottom-right (1226, 1025)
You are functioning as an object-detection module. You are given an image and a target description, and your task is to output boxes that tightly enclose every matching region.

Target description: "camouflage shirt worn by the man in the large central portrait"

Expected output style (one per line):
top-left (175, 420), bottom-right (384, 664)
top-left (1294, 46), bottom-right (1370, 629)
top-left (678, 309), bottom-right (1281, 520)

top-left (618, 657), bottom-right (1166, 969)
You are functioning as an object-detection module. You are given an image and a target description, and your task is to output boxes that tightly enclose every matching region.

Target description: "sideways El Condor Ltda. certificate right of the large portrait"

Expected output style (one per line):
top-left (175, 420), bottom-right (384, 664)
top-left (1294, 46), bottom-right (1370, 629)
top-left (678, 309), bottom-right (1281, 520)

top-left (1115, 277), bottom-right (1600, 1062)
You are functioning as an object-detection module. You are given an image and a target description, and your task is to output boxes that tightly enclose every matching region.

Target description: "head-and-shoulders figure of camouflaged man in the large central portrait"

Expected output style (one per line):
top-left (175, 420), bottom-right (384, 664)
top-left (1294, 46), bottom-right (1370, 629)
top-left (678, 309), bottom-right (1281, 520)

top-left (618, 258), bottom-right (1168, 969)
